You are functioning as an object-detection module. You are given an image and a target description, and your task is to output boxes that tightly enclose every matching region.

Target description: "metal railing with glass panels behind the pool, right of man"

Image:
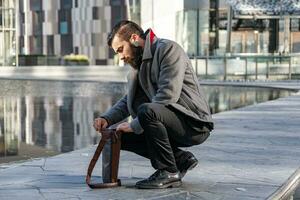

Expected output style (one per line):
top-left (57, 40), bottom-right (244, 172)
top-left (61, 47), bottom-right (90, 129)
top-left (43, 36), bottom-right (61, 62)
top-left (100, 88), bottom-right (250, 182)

top-left (191, 53), bottom-right (300, 80)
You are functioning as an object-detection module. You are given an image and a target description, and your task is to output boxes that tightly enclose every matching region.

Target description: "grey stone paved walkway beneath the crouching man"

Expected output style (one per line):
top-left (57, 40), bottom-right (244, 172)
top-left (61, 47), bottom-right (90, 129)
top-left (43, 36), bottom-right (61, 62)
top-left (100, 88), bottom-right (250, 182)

top-left (0, 81), bottom-right (300, 200)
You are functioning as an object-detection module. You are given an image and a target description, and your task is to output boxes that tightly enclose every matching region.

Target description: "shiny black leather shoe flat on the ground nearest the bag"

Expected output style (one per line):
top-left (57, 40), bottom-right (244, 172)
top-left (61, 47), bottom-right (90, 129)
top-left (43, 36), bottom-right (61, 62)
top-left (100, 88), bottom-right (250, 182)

top-left (135, 169), bottom-right (181, 189)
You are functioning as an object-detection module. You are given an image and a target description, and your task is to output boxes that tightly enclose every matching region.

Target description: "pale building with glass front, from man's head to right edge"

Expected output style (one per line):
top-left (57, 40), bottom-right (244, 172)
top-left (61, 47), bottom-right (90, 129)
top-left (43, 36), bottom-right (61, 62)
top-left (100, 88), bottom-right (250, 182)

top-left (141, 0), bottom-right (300, 56)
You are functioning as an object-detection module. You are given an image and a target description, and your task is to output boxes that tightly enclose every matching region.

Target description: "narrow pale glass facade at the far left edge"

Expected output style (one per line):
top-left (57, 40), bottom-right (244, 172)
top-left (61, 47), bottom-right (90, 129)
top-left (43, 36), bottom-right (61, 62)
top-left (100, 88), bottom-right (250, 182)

top-left (0, 0), bottom-right (17, 66)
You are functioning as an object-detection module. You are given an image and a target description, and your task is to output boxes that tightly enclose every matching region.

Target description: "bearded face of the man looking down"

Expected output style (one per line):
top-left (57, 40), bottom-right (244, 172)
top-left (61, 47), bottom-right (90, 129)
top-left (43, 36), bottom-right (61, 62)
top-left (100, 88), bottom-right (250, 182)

top-left (111, 35), bottom-right (143, 69)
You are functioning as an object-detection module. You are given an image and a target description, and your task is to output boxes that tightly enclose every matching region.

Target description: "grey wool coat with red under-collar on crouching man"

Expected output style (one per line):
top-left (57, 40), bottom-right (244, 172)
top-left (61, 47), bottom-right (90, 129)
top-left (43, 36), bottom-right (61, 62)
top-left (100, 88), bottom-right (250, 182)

top-left (101, 30), bottom-right (213, 134)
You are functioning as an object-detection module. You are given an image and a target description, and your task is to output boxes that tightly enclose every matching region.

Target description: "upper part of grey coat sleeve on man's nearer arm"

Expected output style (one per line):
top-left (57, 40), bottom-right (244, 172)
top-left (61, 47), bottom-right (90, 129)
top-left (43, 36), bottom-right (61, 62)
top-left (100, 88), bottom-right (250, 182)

top-left (152, 43), bottom-right (186, 105)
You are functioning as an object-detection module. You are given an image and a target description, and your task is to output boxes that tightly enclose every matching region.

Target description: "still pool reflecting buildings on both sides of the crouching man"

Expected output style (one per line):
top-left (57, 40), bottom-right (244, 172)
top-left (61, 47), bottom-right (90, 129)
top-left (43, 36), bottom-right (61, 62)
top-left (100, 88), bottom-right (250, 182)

top-left (0, 80), bottom-right (292, 164)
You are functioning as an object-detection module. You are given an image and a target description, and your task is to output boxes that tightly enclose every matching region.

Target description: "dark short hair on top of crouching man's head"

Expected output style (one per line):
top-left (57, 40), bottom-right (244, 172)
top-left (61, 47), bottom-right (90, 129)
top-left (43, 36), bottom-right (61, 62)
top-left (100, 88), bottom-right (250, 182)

top-left (107, 20), bottom-right (144, 47)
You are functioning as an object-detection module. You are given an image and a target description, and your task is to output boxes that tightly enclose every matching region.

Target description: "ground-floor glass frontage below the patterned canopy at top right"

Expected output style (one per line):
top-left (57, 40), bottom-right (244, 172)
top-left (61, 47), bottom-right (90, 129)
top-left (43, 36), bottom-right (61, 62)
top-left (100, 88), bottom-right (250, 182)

top-left (227, 16), bottom-right (300, 53)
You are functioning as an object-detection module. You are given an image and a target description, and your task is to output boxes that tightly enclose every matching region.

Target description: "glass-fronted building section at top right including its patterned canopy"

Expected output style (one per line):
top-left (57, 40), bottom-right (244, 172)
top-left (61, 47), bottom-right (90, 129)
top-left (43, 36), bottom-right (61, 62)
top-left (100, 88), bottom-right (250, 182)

top-left (228, 0), bottom-right (300, 53)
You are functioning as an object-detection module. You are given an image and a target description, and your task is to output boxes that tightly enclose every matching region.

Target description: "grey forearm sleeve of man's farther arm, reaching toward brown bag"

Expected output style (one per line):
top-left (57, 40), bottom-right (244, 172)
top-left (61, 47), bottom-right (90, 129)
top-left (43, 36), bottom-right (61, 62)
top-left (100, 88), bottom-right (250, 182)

top-left (100, 95), bottom-right (129, 126)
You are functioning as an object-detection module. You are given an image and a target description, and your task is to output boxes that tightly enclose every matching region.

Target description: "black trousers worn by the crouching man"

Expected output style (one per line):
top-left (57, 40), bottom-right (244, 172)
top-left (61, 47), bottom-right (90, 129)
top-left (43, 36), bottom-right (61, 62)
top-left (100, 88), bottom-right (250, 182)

top-left (121, 103), bottom-right (210, 171)
